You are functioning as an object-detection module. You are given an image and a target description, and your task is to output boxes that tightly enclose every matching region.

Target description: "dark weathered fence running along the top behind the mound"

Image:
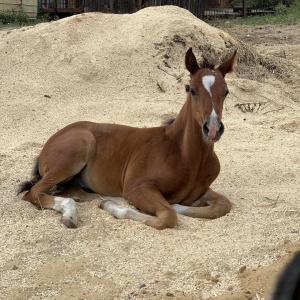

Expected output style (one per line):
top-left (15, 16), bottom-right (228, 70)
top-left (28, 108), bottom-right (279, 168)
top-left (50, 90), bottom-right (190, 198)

top-left (11, 0), bottom-right (276, 19)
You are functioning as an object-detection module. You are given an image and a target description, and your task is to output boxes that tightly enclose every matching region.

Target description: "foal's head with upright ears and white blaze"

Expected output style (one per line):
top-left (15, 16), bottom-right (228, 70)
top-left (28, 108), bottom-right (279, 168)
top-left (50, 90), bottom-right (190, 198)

top-left (185, 48), bottom-right (236, 142)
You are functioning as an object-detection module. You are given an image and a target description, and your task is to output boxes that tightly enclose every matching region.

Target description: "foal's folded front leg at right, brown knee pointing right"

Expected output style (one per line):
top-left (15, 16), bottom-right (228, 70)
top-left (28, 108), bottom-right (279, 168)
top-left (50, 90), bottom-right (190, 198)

top-left (172, 189), bottom-right (231, 219)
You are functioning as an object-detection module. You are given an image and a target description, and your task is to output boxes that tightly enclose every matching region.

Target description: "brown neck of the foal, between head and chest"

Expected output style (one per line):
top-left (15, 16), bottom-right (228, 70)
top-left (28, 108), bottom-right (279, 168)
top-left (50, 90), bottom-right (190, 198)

top-left (169, 96), bottom-right (214, 162)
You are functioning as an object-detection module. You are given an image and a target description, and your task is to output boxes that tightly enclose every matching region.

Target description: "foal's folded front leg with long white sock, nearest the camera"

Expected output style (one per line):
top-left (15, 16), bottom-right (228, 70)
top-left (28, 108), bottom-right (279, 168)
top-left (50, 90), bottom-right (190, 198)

top-left (100, 186), bottom-right (177, 229)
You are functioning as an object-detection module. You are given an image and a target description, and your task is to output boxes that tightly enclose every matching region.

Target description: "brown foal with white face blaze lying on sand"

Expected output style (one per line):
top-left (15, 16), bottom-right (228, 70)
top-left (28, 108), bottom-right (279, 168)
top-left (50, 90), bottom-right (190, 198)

top-left (19, 49), bottom-right (236, 229)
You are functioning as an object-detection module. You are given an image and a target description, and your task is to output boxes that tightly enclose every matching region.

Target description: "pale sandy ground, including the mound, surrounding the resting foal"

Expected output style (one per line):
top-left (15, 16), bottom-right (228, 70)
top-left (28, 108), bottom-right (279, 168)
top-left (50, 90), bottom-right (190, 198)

top-left (0, 7), bottom-right (300, 300)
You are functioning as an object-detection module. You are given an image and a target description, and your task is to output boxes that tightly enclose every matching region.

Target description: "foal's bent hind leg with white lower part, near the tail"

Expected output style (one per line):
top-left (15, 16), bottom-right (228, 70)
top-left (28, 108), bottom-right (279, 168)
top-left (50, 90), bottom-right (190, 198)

top-left (21, 123), bottom-right (95, 227)
